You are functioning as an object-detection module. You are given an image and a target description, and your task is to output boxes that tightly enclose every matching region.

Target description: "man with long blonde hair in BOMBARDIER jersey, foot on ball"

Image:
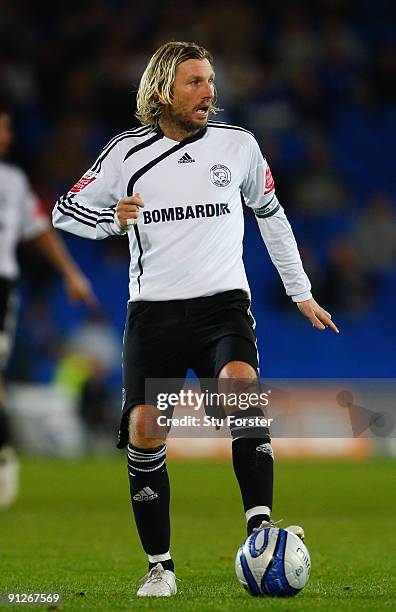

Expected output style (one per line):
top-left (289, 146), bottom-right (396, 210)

top-left (53, 42), bottom-right (338, 596)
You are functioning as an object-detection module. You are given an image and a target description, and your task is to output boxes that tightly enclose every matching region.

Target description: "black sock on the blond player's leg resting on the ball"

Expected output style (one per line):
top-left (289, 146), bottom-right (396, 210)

top-left (232, 438), bottom-right (274, 535)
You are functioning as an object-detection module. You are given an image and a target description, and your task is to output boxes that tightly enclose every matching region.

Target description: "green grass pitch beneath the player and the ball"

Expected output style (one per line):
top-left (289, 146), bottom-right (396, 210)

top-left (0, 456), bottom-right (396, 612)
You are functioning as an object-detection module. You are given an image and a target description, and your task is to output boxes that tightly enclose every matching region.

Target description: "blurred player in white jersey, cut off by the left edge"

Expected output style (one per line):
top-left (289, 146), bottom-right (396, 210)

top-left (0, 101), bottom-right (96, 508)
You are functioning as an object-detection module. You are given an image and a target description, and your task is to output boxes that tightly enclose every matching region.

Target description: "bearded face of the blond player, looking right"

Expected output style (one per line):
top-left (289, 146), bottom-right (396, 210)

top-left (160, 59), bottom-right (214, 138)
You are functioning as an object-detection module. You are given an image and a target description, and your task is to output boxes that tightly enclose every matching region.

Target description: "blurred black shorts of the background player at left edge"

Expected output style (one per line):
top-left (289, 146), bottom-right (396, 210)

top-left (0, 276), bottom-right (18, 372)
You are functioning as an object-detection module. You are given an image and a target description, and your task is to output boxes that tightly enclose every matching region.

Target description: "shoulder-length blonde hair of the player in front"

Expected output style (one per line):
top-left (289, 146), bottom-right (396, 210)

top-left (136, 42), bottom-right (220, 128)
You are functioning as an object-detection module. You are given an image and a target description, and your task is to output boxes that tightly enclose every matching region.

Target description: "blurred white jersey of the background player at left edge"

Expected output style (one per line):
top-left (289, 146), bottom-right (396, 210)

top-left (0, 162), bottom-right (49, 279)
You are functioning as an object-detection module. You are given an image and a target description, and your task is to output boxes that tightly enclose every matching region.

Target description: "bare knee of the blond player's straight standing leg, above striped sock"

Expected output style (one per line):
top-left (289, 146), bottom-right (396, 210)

top-left (128, 405), bottom-right (166, 448)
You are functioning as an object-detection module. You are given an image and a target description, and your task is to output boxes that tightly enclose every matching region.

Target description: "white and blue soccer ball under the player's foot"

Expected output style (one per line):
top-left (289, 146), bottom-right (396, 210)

top-left (235, 527), bottom-right (311, 597)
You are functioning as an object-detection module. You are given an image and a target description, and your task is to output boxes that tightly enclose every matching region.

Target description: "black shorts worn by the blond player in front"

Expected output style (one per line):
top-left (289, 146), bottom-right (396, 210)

top-left (117, 289), bottom-right (258, 448)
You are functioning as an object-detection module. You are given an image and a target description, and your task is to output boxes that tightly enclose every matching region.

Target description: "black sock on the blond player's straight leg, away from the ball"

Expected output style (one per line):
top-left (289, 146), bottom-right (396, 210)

top-left (128, 444), bottom-right (174, 571)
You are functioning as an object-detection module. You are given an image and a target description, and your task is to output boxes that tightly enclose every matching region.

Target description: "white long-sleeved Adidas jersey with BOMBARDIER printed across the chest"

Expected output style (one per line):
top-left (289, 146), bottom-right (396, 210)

top-left (53, 121), bottom-right (310, 301)
